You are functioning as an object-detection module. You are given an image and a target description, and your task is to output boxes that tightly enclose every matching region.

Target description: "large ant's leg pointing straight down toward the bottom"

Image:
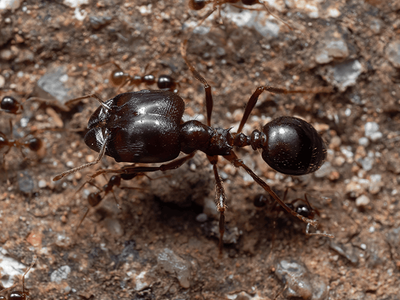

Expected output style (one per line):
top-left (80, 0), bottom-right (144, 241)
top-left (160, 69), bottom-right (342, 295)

top-left (207, 155), bottom-right (226, 255)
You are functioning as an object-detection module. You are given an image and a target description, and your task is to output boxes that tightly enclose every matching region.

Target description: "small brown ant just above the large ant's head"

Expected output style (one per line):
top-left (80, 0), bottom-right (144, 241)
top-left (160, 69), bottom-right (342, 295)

top-left (104, 62), bottom-right (179, 92)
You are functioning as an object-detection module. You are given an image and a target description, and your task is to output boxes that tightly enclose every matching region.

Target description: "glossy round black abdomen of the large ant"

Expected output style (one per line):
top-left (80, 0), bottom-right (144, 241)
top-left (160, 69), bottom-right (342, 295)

top-left (262, 117), bottom-right (326, 175)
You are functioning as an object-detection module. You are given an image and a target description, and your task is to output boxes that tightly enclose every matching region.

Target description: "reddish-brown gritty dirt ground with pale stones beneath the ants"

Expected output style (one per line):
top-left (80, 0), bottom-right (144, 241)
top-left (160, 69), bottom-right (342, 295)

top-left (0, 0), bottom-right (400, 300)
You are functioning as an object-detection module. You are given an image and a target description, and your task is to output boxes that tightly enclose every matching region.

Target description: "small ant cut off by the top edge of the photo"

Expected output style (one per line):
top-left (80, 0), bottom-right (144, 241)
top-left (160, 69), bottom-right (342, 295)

top-left (188, 0), bottom-right (292, 30)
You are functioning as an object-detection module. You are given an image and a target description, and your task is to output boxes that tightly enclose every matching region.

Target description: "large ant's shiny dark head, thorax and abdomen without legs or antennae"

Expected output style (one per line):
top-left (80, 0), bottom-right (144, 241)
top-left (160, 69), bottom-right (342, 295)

top-left (85, 90), bottom-right (326, 175)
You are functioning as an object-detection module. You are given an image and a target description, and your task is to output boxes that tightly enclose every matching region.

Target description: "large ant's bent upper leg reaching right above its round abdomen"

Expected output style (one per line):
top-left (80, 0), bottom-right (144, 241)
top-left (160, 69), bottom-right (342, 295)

top-left (237, 85), bottom-right (332, 133)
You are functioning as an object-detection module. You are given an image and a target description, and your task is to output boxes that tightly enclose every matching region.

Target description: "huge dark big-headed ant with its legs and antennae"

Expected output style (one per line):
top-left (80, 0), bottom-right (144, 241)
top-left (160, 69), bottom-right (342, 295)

top-left (53, 40), bottom-right (331, 254)
